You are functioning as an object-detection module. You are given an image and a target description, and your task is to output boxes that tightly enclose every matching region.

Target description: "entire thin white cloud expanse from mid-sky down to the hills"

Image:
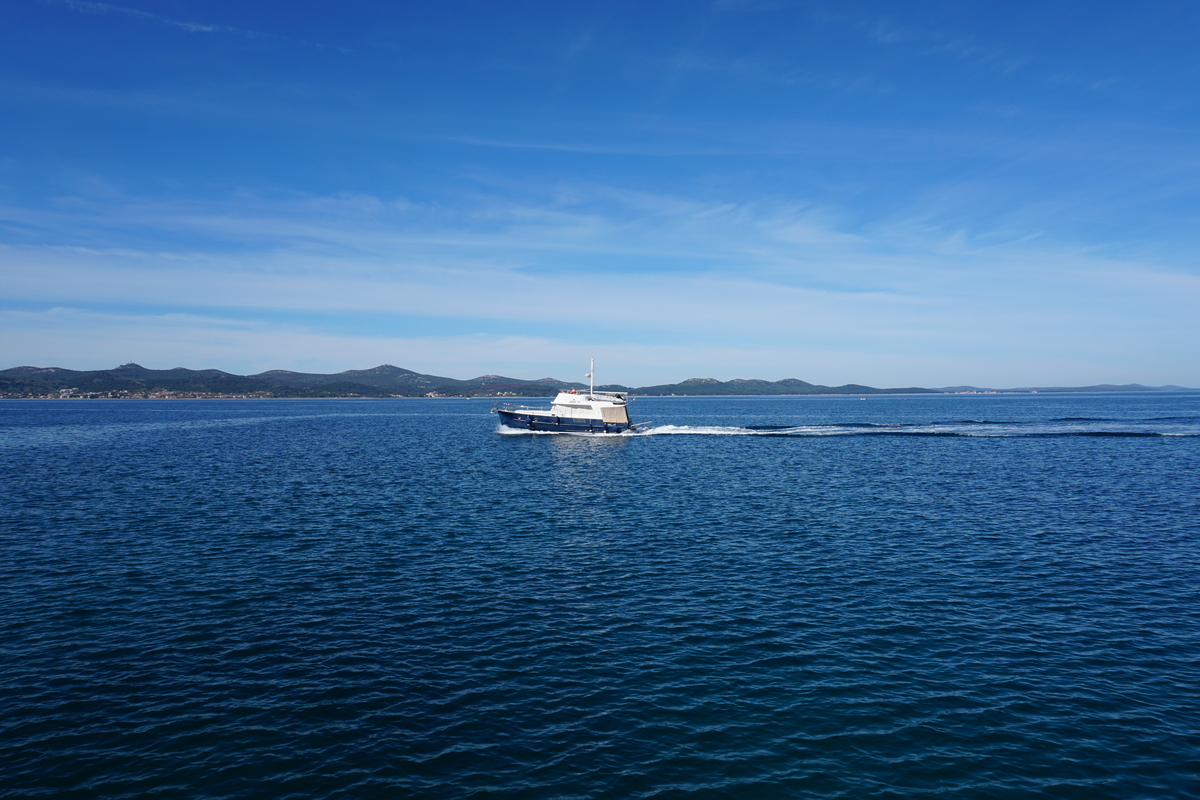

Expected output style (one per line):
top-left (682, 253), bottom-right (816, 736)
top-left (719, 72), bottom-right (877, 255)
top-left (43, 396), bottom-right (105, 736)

top-left (0, 172), bottom-right (1200, 385)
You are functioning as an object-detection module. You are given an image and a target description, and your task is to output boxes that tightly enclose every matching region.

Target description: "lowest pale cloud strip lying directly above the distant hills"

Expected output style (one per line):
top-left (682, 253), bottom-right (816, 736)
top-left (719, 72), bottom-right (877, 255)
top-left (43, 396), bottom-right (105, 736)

top-left (0, 299), bottom-right (1200, 386)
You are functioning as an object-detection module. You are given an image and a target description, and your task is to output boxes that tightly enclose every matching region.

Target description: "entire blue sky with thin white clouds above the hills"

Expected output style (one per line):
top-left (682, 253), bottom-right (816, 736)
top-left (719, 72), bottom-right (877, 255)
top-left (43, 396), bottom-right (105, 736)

top-left (0, 0), bottom-right (1200, 387)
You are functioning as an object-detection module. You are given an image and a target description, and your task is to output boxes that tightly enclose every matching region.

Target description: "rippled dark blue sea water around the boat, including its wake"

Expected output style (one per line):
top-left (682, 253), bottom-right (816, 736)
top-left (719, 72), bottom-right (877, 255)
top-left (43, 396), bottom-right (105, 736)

top-left (0, 393), bottom-right (1200, 799)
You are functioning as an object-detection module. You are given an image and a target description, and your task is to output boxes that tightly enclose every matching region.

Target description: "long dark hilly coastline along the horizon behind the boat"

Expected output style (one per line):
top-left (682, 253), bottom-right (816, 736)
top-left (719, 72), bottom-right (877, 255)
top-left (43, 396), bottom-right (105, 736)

top-left (0, 363), bottom-right (1189, 399)
